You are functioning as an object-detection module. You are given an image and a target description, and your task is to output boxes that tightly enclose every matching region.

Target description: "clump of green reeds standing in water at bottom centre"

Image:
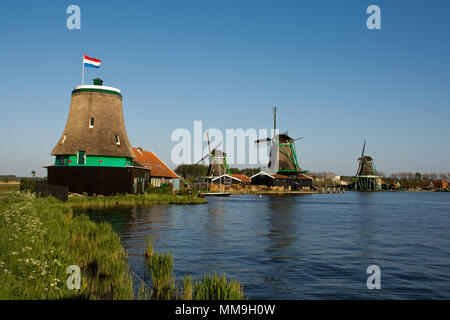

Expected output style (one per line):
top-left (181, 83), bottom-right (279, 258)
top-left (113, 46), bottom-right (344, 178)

top-left (146, 239), bottom-right (247, 300)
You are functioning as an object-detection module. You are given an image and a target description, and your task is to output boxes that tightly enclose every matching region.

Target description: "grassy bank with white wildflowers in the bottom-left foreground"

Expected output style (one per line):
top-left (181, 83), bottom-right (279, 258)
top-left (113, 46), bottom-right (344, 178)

top-left (0, 193), bottom-right (133, 299)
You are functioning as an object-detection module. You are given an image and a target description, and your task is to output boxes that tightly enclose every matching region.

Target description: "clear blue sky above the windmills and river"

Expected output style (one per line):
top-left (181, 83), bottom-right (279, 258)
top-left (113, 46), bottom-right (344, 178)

top-left (0, 0), bottom-right (450, 176)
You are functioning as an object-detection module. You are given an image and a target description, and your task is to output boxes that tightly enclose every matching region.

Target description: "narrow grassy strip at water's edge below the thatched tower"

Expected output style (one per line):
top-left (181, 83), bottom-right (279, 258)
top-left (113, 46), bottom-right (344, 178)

top-left (68, 194), bottom-right (207, 209)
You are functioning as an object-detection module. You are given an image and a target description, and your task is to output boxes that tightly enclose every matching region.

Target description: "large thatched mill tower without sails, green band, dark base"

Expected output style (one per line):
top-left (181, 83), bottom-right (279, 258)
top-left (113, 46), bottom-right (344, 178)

top-left (47, 79), bottom-right (150, 195)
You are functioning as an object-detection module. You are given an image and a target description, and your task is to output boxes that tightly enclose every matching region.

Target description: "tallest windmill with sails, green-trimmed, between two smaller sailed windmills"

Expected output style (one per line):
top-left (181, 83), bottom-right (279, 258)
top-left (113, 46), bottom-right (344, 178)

top-left (255, 107), bottom-right (308, 175)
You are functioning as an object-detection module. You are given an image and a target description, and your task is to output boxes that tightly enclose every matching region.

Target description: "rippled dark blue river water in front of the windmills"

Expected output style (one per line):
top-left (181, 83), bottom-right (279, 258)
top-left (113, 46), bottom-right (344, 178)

top-left (76, 192), bottom-right (450, 299)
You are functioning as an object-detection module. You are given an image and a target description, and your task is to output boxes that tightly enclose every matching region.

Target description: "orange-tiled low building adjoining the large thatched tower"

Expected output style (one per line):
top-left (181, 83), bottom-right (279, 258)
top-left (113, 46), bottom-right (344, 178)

top-left (133, 147), bottom-right (179, 187)
